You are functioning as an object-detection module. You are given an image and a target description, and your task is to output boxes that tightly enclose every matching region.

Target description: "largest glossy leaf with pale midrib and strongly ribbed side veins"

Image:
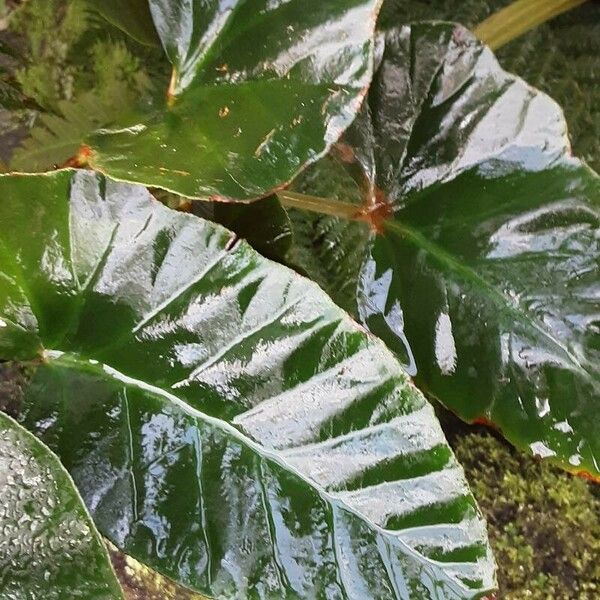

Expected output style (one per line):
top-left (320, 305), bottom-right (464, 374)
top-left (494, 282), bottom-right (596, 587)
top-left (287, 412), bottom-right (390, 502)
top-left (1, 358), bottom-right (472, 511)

top-left (0, 171), bottom-right (494, 600)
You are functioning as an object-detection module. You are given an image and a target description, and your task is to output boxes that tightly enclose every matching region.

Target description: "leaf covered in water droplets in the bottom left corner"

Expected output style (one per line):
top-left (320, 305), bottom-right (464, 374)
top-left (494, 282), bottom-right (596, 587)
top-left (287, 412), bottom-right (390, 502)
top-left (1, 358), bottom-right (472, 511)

top-left (0, 413), bottom-right (123, 600)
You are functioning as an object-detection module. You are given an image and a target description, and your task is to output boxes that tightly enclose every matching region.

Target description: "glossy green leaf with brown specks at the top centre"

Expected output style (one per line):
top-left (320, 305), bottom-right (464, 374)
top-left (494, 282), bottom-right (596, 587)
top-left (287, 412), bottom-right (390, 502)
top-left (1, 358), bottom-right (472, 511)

top-left (80, 0), bottom-right (380, 199)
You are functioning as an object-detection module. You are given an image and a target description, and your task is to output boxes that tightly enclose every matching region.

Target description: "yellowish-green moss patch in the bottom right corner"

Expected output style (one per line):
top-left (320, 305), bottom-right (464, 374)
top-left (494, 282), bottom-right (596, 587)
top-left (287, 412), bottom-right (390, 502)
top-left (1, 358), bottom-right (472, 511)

top-left (452, 428), bottom-right (600, 600)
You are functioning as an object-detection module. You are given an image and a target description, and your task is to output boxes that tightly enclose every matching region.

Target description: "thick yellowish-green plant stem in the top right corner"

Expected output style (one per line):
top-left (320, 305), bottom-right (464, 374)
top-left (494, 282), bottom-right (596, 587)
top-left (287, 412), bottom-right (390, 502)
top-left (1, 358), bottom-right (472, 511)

top-left (474, 0), bottom-right (587, 50)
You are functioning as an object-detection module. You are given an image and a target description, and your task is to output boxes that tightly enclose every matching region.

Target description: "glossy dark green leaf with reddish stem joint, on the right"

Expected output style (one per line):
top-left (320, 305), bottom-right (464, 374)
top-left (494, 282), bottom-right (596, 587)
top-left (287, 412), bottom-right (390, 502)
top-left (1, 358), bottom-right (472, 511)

top-left (290, 23), bottom-right (600, 476)
